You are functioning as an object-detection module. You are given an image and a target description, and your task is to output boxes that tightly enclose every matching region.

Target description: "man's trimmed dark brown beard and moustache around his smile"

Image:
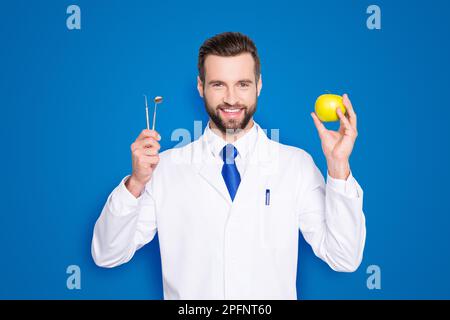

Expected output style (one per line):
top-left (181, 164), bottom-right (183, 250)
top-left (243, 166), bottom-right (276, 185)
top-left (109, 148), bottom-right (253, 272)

top-left (203, 95), bottom-right (258, 134)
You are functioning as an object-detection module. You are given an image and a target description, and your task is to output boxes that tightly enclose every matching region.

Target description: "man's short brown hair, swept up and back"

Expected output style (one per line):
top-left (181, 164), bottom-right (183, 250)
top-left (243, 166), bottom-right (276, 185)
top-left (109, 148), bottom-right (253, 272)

top-left (198, 32), bottom-right (261, 83)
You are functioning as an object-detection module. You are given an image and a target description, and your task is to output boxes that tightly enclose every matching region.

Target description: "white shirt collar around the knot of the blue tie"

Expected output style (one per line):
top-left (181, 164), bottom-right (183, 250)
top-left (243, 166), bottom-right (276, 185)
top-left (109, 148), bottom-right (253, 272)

top-left (204, 121), bottom-right (258, 159)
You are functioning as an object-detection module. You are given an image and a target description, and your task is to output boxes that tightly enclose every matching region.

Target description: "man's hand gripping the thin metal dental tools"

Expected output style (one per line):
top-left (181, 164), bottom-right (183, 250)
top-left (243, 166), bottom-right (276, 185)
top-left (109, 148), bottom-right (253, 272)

top-left (125, 129), bottom-right (161, 198)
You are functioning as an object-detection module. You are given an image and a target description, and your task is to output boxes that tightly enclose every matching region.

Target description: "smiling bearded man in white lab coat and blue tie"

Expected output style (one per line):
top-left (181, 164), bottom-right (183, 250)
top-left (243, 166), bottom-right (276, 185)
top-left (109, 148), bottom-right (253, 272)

top-left (92, 32), bottom-right (366, 299)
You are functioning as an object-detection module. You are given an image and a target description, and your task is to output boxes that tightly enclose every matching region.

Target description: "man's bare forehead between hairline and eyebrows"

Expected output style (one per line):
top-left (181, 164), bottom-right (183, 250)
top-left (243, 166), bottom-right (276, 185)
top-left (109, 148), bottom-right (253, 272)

top-left (205, 52), bottom-right (255, 81)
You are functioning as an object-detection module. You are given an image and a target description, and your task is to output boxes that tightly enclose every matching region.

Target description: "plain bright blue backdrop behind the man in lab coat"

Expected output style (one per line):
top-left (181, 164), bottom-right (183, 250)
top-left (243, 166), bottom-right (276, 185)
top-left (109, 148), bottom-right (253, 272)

top-left (0, 0), bottom-right (450, 299)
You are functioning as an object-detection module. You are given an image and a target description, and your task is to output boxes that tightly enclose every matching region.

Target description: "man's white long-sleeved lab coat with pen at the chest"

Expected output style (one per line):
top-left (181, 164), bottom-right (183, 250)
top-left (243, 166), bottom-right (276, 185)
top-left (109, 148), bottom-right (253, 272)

top-left (92, 124), bottom-right (366, 299)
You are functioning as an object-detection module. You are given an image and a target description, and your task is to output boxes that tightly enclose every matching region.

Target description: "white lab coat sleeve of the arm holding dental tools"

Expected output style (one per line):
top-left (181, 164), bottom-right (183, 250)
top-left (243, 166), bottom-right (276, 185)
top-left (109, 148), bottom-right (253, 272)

top-left (91, 176), bottom-right (157, 268)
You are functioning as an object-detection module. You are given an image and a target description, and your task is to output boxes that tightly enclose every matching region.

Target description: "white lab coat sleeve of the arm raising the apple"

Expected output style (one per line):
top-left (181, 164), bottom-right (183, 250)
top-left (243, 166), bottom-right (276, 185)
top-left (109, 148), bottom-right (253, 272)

top-left (298, 153), bottom-right (366, 272)
